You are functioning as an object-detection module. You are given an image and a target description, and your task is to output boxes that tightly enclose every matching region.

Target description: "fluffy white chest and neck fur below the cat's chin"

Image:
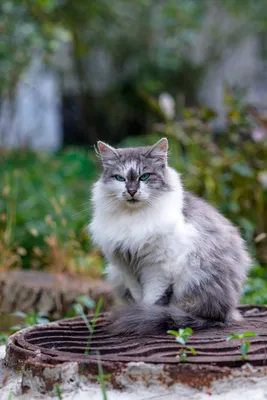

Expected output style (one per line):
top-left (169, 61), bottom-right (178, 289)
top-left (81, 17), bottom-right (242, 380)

top-left (90, 168), bottom-right (201, 303)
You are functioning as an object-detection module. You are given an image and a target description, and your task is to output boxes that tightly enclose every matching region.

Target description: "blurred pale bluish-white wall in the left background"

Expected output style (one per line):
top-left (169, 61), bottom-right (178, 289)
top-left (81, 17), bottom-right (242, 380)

top-left (0, 60), bottom-right (62, 151)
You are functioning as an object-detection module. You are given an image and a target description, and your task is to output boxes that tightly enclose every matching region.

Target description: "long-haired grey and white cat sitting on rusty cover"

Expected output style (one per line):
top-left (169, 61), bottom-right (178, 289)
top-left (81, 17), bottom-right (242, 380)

top-left (90, 138), bottom-right (250, 334)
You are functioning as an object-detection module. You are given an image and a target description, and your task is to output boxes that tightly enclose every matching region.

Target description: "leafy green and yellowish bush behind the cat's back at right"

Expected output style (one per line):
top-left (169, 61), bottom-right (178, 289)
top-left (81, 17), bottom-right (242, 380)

top-left (148, 87), bottom-right (267, 304)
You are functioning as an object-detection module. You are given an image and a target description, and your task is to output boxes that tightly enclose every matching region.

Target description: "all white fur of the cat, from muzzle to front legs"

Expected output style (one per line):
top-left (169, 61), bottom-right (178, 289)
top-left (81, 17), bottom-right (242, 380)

top-left (89, 167), bottom-right (202, 304)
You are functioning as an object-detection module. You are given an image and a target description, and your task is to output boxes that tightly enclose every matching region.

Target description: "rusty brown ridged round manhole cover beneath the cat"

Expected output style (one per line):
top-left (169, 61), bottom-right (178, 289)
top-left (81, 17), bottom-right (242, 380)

top-left (6, 306), bottom-right (267, 387)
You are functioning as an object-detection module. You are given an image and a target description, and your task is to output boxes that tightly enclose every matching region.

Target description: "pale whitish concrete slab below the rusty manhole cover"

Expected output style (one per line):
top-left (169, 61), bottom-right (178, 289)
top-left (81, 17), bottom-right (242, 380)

top-left (0, 346), bottom-right (267, 400)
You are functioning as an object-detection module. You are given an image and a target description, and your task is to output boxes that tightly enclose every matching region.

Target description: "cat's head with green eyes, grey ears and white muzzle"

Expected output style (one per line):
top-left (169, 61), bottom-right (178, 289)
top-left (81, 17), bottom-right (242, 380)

top-left (97, 138), bottom-right (170, 208)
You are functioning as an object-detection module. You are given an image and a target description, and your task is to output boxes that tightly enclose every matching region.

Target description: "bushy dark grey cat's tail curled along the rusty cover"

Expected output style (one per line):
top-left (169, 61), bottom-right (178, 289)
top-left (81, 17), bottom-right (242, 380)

top-left (109, 304), bottom-right (225, 336)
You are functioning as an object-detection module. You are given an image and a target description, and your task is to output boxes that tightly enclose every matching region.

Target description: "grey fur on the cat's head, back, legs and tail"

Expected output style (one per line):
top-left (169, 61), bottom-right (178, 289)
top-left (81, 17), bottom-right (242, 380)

top-left (91, 139), bottom-right (250, 335)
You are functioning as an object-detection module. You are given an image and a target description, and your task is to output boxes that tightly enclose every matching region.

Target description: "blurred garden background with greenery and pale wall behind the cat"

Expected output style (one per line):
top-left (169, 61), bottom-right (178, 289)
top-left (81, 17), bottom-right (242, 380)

top-left (0, 0), bottom-right (267, 324)
